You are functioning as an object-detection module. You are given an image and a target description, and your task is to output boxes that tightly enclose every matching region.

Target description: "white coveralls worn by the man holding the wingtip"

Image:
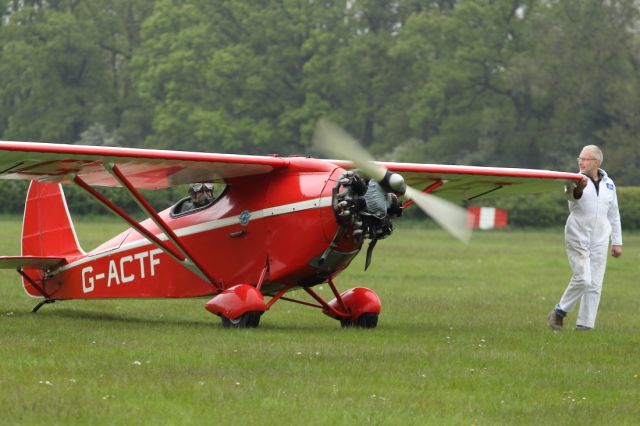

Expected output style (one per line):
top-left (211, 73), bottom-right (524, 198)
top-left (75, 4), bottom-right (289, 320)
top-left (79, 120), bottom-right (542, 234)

top-left (557, 169), bottom-right (622, 328)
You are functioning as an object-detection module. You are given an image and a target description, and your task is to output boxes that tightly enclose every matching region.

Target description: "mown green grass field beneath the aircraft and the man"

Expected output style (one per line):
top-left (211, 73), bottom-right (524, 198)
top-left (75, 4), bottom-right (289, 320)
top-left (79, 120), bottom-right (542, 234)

top-left (0, 218), bottom-right (640, 425)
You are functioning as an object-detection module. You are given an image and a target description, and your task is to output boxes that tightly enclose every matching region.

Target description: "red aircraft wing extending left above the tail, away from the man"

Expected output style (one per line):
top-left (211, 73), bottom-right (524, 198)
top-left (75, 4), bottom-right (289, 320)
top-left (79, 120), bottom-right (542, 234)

top-left (0, 141), bottom-right (288, 189)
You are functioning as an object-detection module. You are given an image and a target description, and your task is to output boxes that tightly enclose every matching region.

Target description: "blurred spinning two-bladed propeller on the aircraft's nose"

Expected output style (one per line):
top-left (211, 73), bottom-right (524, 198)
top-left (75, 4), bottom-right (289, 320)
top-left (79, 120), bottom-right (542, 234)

top-left (313, 119), bottom-right (471, 243)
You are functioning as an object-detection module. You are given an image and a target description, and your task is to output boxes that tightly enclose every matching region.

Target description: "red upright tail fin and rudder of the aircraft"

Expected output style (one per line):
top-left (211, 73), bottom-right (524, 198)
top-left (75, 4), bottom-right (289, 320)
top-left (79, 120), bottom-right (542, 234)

top-left (22, 181), bottom-right (85, 296)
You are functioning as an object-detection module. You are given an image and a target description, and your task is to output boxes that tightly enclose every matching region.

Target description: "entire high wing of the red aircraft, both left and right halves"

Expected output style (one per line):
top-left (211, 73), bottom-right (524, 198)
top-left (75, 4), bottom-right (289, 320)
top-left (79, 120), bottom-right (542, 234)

top-left (0, 141), bottom-right (581, 198)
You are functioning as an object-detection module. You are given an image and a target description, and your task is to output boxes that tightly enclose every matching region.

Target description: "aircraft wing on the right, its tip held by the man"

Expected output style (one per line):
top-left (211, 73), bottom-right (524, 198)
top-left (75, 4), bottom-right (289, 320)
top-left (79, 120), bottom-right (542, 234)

top-left (334, 161), bottom-right (582, 202)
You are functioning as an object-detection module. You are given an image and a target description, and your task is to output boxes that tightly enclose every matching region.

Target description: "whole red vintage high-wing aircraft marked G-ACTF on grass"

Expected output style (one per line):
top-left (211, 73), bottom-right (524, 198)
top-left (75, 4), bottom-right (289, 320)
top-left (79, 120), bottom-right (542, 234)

top-left (0, 122), bottom-right (580, 328)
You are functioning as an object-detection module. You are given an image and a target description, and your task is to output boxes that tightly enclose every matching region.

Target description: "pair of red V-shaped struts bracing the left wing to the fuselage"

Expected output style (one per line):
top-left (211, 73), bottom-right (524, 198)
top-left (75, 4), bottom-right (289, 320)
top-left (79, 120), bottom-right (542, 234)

top-left (73, 171), bottom-right (222, 289)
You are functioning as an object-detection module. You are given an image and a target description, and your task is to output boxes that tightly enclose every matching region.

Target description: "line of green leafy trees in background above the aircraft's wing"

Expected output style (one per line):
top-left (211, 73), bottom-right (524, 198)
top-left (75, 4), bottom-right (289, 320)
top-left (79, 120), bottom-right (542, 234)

top-left (0, 0), bottom-right (640, 185)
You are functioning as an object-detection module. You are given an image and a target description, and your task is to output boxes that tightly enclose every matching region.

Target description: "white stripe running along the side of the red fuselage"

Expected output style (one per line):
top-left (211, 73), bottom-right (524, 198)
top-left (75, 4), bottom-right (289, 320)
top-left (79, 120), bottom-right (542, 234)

top-left (54, 197), bottom-right (331, 274)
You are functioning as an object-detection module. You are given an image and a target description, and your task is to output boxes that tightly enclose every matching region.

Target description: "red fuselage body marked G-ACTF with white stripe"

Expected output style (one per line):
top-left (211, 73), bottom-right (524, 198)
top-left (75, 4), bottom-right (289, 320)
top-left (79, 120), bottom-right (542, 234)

top-left (40, 158), bottom-right (362, 299)
